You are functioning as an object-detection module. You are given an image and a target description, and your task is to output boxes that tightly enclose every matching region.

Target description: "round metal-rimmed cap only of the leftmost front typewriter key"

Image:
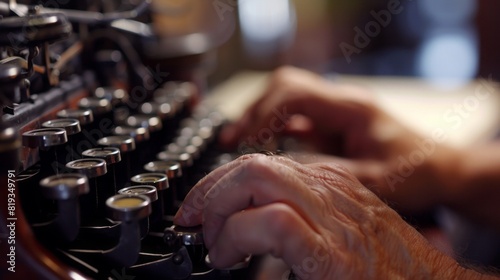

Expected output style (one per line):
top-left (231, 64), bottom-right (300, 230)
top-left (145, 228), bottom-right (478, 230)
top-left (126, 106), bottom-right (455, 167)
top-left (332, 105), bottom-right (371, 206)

top-left (40, 173), bottom-right (89, 200)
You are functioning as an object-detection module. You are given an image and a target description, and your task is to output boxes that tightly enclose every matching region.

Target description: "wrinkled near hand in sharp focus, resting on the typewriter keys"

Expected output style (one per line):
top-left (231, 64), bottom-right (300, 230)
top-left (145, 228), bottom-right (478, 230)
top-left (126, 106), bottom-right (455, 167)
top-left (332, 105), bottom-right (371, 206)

top-left (174, 154), bottom-right (465, 279)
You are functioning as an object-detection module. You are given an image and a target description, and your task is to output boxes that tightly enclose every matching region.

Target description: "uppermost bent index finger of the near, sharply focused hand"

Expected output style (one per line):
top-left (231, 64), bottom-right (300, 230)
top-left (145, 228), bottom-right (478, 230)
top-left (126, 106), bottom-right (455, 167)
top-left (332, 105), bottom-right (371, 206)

top-left (199, 157), bottom-right (319, 246)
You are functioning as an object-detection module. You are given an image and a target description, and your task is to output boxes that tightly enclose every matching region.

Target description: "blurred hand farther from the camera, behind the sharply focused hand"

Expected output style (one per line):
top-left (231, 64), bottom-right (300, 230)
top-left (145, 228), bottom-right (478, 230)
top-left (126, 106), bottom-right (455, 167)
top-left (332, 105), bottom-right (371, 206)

top-left (220, 67), bottom-right (457, 211)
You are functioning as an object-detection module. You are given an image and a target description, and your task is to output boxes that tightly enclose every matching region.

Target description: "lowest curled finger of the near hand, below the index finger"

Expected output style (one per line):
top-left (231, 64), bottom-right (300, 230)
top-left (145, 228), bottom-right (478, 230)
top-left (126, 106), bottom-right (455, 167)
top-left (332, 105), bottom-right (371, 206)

top-left (209, 203), bottom-right (334, 279)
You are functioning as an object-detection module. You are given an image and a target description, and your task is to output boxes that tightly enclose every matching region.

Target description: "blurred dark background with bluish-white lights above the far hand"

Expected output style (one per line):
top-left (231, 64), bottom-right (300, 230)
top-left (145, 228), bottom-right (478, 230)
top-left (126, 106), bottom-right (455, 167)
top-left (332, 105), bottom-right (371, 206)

top-left (211, 0), bottom-right (500, 87)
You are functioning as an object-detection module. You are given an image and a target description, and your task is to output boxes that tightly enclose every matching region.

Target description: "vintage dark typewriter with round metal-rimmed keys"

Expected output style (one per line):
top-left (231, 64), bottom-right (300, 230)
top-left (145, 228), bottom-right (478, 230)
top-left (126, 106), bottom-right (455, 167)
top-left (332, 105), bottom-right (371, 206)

top-left (0, 0), bottom-right (278, 279)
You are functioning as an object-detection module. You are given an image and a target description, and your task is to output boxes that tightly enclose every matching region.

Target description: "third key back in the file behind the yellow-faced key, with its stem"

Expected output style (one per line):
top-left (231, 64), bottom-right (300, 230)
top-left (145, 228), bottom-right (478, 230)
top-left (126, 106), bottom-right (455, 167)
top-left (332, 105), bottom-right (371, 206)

top-left (130, 173), bottom-right (170, 223)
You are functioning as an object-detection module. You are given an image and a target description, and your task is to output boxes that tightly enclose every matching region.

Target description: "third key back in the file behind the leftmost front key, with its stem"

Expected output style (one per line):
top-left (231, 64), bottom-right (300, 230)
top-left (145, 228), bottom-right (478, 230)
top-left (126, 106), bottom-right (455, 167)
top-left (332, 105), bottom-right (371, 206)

top-left (82, 147), bottom-right (121, 198)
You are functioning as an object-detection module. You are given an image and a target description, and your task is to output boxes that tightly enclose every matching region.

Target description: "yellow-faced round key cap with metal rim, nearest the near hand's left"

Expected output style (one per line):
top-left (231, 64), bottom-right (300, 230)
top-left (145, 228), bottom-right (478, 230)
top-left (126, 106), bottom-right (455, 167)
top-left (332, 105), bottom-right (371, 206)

top-left (106, 194), bottom-right (151, 222)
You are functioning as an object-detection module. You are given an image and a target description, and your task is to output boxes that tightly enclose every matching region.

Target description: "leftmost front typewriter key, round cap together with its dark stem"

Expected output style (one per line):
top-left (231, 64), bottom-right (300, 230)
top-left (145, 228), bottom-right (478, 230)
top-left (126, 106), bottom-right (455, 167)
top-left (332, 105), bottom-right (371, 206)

top-left (33, 173), bottom-right (89, 243)
